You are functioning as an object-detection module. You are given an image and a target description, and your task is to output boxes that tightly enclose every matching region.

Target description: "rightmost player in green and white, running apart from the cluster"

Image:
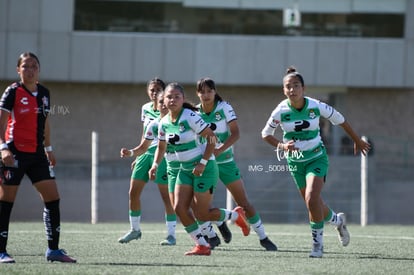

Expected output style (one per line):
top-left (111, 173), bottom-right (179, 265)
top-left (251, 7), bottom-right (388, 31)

top-left (262, 67), bottom-right (370, 258)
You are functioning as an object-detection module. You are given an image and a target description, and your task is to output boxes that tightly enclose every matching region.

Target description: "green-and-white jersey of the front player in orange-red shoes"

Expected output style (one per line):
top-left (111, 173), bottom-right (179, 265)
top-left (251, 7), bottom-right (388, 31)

top-left (158, 108), bottom-right (208, 162)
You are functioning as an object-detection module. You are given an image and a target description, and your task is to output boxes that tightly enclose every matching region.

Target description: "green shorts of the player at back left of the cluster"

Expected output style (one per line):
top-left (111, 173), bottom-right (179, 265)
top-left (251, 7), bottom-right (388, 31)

top-left (131, 154), bottom-right (168, 184)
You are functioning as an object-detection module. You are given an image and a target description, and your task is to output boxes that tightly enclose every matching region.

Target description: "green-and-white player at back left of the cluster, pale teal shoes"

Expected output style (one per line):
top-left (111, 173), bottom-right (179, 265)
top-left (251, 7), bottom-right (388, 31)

top-left (118, 78), bottom-right (177, 245)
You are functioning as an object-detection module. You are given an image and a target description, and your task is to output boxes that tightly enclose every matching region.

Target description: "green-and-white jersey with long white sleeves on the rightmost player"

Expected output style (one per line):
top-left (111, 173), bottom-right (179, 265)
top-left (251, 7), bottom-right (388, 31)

top-left (262, 97), bottom-right (345, 161)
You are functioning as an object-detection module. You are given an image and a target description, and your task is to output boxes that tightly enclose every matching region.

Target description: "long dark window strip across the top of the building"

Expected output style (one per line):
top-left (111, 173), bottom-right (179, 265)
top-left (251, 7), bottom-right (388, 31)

top-left (74, 0), bottom-right (405, 38)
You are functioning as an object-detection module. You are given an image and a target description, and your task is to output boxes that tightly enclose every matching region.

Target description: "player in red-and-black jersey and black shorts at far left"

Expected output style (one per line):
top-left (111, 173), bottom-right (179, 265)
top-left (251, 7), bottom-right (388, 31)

top-left (0, 52), bottom-right (76, 263)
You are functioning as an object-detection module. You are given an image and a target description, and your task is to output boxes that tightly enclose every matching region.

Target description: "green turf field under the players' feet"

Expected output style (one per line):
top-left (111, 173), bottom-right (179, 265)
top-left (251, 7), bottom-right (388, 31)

top-left (0, 222), bottom-right (414, 275)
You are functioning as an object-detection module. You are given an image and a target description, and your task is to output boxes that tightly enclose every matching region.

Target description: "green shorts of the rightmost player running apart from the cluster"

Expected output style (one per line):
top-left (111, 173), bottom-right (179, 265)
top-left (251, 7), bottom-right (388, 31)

top-left (288, 152), bottom-right (329, 189)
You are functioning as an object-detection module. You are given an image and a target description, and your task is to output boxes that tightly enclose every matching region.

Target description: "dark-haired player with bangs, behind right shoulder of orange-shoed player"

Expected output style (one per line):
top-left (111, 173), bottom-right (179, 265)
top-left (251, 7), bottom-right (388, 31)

top-left (197, 78), bottom-right (277, 251)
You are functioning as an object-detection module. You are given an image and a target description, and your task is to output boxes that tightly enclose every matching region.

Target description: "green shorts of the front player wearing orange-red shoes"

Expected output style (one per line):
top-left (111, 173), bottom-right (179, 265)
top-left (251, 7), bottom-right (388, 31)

top-left (176, 160), bottom-right (218, 193)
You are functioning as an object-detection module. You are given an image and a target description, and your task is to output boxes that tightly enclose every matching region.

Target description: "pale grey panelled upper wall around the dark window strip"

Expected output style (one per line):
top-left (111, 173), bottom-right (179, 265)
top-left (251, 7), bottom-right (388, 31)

top-left (0, 0), bottom-right (414, 87)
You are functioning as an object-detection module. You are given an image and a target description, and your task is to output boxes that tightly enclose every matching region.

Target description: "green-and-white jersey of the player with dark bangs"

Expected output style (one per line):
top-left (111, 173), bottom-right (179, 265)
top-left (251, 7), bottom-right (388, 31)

top-left (197, 101), bottom-right (237, 164)
